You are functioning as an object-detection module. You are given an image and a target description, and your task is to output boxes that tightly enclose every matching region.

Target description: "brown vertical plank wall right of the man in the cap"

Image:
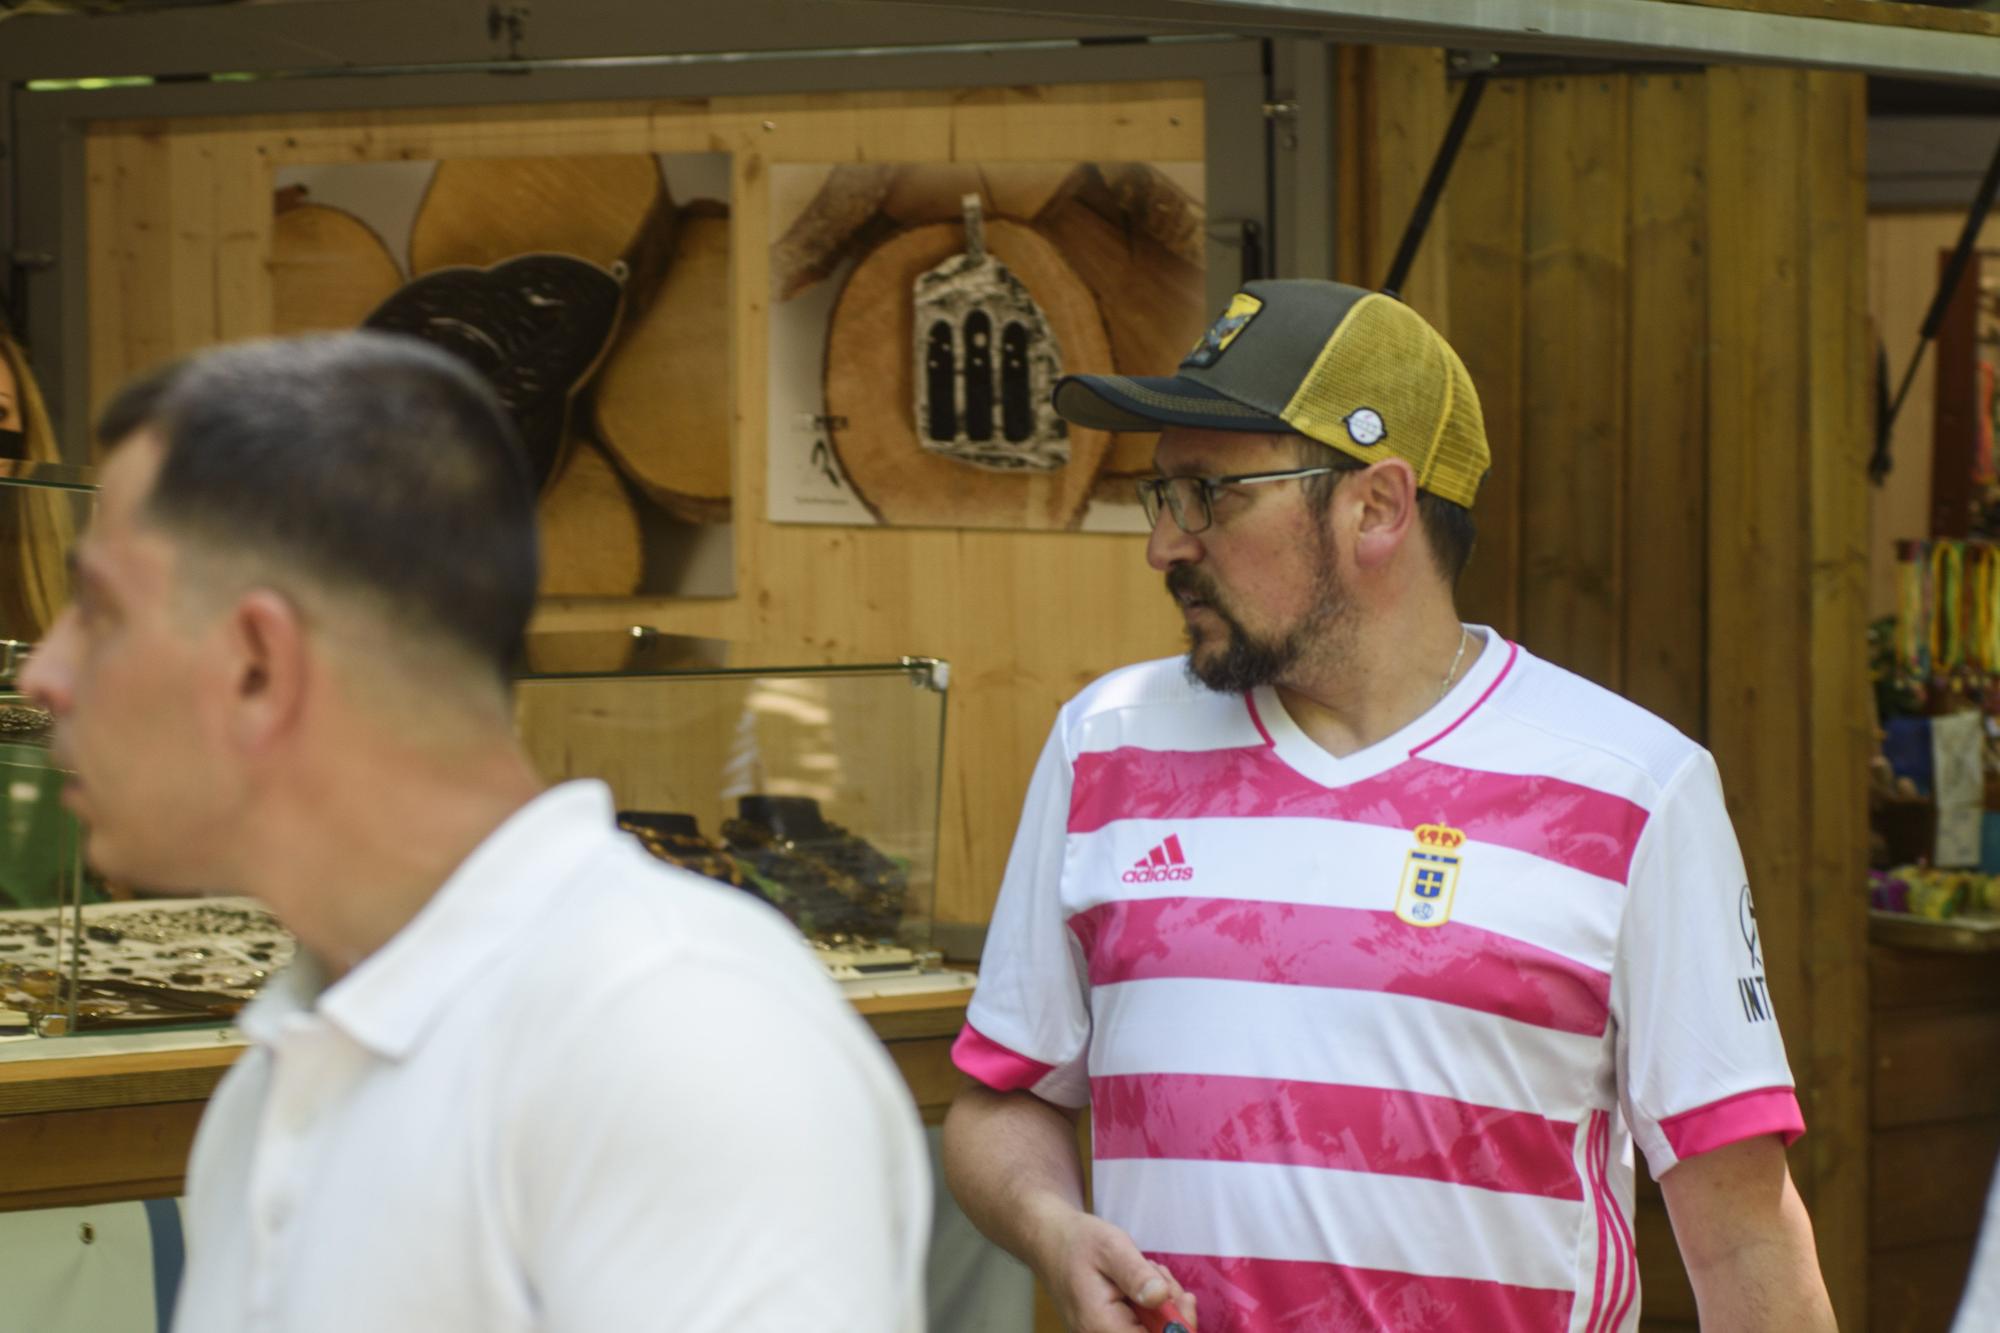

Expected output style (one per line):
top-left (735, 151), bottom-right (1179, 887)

top-left (1376, 64), bottom-right (1872, 1329)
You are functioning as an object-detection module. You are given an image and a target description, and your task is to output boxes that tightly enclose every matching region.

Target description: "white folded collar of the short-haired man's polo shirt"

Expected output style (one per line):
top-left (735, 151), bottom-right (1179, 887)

top-left (238, 781), bottom-right (616, 1061)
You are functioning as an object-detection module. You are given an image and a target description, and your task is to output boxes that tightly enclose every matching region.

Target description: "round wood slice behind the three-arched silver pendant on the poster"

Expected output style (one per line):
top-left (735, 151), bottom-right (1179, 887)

top-left (826, 218), bottom-right (1112, 528)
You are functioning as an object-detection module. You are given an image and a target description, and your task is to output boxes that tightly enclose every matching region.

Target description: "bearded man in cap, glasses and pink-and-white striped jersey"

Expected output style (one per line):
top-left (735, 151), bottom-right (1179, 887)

top-left (946, 280), bottom-right (1834, 1333)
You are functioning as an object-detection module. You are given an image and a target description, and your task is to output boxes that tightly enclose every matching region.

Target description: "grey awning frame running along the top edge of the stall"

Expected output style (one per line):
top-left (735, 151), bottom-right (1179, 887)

top-left (0, 0), bottom-right (2000, 88)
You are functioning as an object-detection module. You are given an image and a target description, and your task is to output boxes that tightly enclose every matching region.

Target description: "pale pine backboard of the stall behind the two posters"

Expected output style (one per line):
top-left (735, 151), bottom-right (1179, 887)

top-left (86, 82), bottom-right (1202, 921)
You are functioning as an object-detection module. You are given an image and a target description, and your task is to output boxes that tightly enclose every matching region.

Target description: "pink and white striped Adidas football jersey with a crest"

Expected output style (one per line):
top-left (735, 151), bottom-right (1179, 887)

top-left (954, 630), bottom-right (1804, 1333)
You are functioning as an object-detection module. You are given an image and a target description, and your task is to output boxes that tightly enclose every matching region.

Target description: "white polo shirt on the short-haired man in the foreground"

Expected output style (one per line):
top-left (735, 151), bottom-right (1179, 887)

top-left (174, 783), bottom-right (930, 1333)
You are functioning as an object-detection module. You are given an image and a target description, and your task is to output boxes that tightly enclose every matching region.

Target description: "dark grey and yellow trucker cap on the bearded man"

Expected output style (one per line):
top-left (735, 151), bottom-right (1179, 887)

top-left (1056, 278), bottom-right (1492, 508)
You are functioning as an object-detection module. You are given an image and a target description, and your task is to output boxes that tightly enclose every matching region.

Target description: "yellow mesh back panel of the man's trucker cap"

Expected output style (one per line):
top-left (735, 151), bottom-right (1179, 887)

top-left (1282, 294), bottom-right (1488, 508)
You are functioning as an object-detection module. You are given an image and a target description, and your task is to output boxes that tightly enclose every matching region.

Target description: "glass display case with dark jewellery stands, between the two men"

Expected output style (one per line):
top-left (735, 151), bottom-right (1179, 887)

top-left (514, 628), bottom-right (968, 993)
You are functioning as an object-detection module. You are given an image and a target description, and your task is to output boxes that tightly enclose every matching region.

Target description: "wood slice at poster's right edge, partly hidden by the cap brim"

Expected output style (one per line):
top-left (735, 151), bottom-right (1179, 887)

top-left (1034, 189), bottom-right (1208, 474)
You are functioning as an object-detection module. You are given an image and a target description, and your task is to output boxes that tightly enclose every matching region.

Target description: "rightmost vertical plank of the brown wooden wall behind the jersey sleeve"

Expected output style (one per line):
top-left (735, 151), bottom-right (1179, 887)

top-left (1800, 70), bottom-right (1876, 1323)
